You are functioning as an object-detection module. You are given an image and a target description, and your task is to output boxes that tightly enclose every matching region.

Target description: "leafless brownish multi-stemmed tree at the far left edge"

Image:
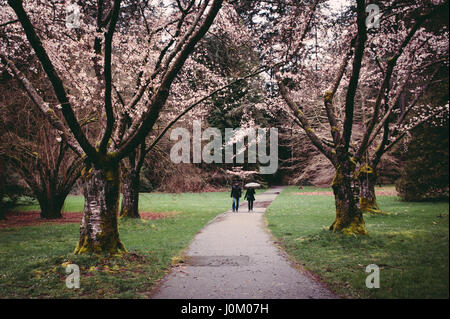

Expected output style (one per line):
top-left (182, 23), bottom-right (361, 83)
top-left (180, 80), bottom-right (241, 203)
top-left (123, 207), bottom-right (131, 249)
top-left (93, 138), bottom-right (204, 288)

top-left (0, 109), bottom-right (83, 218)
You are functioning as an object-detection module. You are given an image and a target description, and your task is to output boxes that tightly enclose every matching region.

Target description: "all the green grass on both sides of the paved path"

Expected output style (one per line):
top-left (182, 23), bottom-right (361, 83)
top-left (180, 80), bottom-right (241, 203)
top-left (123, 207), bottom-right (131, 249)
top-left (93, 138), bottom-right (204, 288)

top-left (0, 187), bottom-right (449, 298)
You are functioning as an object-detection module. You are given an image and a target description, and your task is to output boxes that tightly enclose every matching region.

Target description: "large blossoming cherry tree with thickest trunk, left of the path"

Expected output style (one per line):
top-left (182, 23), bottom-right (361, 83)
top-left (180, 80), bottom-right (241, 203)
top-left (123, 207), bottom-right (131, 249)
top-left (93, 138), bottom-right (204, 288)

top-left (0, 0), bottom-right (222, 254)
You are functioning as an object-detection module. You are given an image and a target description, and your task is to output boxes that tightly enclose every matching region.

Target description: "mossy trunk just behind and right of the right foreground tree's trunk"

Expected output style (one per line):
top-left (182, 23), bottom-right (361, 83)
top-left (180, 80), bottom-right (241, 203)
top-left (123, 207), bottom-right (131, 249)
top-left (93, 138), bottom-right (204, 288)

top-left (358, 164), bottom-right (381, 213)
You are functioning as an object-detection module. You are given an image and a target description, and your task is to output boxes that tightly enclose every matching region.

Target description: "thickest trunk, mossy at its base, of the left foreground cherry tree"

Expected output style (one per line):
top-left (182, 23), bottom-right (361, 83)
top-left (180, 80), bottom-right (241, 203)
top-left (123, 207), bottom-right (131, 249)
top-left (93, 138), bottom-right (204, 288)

top-left (74, 164), bottom-right (126, 254)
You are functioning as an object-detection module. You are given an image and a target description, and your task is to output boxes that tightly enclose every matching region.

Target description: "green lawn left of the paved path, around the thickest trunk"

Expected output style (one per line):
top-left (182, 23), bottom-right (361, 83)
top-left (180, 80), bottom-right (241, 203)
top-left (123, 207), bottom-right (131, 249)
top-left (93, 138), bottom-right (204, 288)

top-left (0, 192), bottom-right (230, 298)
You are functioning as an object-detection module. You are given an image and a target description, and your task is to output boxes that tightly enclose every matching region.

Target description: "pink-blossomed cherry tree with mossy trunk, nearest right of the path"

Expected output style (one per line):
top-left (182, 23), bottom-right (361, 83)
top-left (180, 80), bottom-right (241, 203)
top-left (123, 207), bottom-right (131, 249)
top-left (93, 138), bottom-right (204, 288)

top-left (237, 0), bottom-right (448, 234)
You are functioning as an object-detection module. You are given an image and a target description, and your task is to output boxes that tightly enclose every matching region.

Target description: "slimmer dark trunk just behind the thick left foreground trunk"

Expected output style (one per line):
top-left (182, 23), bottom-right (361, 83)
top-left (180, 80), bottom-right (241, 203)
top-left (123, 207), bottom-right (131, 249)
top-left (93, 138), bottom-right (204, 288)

top-left (120, 168), bottom-right (140, 218)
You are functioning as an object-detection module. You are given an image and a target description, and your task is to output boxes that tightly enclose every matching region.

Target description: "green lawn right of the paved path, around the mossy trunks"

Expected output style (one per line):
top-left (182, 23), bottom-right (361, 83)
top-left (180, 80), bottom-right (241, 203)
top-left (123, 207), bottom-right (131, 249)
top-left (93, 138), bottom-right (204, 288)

top-left (266, 187), bottom-right (449, 298)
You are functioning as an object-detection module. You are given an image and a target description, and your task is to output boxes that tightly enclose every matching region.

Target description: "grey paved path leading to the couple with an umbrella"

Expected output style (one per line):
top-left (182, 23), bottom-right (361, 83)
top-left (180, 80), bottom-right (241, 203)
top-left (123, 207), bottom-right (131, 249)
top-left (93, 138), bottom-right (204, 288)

top-left (151, 187), bottom-right (337, 299)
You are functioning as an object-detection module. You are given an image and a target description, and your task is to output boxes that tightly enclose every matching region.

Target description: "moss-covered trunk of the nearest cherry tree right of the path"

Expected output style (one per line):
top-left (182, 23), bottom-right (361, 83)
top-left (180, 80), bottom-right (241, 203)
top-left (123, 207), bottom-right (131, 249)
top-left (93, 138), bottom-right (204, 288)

top-left (330, 160), bottom-right (367, 235)
